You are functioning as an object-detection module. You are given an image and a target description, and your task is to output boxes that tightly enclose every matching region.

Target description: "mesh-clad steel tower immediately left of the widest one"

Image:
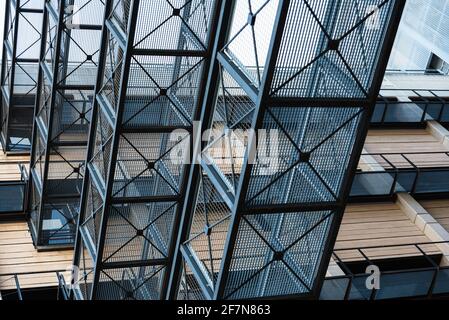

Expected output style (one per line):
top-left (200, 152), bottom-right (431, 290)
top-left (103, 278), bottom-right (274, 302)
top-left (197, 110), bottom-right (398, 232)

top-left (70, 0), bottom-right (219, 300)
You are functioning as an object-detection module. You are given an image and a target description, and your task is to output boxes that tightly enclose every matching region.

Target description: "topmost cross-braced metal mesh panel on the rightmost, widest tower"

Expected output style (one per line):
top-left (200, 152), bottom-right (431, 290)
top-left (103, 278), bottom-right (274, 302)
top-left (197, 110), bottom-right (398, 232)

top-left (271, 0), bottom-right (392, 98)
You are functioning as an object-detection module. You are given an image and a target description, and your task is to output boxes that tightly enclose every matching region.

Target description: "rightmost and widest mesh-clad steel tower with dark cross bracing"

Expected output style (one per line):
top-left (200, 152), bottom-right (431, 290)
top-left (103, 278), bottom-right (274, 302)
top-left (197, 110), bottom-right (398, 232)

top-left (168, 0), bottom-right (404, 299)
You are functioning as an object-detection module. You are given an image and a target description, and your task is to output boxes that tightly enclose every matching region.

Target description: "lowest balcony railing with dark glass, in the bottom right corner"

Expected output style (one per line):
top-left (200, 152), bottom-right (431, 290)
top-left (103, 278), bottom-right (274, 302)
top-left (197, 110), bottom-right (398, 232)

top-left (320, 241), bottom-right (449, 300)
